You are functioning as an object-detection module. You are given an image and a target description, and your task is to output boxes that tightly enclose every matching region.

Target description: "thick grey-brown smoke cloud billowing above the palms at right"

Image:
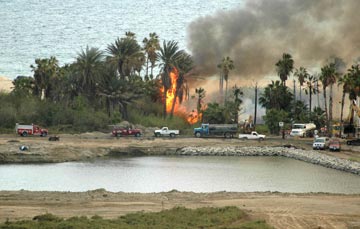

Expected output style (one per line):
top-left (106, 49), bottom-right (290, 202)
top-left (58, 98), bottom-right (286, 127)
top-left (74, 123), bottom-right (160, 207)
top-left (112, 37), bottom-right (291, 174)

top-left (188, 0), bottom-right (360, 80)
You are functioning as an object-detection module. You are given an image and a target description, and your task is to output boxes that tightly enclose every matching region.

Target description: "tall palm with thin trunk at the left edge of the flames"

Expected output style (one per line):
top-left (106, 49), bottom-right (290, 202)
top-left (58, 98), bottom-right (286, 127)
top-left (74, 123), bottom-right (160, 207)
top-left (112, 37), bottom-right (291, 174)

top-left (157, 41), bottom-right (184, 118)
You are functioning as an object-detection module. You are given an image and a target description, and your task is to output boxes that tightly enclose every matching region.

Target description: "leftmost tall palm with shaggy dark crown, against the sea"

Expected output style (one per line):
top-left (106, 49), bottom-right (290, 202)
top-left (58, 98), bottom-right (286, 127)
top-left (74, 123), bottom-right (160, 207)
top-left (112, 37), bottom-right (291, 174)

top-left (30, 56), bottom-right (59, 100)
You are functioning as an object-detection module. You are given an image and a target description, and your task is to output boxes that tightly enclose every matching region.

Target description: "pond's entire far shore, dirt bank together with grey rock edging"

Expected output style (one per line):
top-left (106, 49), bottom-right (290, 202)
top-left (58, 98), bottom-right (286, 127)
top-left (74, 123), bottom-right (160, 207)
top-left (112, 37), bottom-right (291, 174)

top-left (0, 134), bottom-right (360, 175)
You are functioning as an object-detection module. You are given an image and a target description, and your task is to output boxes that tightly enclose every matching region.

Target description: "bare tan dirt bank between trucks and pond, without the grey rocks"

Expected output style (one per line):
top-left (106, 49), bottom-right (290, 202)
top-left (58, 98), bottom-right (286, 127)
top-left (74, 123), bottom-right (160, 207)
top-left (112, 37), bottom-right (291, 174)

top-left (0, 133), bottom-right (360, 163)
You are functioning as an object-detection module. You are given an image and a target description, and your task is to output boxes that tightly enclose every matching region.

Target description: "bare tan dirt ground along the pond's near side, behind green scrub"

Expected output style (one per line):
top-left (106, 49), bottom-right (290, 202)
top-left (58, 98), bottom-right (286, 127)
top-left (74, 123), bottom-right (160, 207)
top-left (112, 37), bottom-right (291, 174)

top-left (0, 189), bottom-right (360, 229)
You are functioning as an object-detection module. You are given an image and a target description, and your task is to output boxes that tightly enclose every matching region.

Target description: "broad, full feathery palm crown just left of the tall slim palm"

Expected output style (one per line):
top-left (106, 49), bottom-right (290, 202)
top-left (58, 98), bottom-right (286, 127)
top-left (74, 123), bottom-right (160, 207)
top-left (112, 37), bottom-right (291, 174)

top-left (106, 32), bottom-right (144, 80)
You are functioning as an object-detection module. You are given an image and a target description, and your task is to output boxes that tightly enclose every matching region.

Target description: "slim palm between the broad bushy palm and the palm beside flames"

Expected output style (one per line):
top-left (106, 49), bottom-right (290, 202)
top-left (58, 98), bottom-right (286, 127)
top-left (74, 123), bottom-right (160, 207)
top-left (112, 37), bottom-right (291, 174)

top-left (143, 33), bottom-right (160, 79)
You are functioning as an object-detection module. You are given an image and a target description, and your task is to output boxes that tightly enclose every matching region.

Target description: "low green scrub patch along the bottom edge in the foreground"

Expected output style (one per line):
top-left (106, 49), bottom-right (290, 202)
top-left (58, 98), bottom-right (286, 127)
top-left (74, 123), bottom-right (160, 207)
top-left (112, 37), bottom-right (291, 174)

top-left (0, 207), bottom-right (272, 229)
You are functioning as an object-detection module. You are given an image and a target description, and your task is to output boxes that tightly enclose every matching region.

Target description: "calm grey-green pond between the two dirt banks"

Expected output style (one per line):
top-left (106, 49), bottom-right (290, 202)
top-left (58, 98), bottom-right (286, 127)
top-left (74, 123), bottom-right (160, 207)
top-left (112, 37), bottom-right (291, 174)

top-left (0, 157), bottom-right (360, 194)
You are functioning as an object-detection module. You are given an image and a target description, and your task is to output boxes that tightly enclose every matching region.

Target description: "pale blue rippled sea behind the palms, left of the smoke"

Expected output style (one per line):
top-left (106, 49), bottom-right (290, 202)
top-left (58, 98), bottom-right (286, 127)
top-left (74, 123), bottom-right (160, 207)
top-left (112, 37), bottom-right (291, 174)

top-left (0, 0), bottom-right (244, 79)
